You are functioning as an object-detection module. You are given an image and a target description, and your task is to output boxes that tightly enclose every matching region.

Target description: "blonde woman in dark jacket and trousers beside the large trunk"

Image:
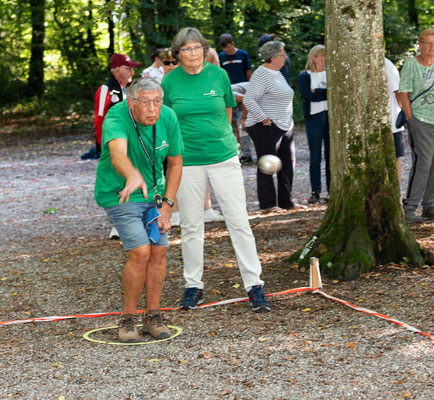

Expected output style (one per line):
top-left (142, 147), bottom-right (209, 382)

top-left (298, 44), bottom-right (330, 204)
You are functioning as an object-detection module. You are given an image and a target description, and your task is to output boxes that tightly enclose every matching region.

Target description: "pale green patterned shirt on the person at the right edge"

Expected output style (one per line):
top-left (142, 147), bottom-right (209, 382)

top-left (399, 57), bottom-right (434, 124)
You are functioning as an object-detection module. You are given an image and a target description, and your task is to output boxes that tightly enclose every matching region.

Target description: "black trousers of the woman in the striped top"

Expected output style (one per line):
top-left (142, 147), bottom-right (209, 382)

top-left (247, 123), bottom-right (295, 209)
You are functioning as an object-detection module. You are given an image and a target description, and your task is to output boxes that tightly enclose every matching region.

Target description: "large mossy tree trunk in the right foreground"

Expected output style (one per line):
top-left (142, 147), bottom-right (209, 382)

top-left (294, 0), bottom-right (424, 279)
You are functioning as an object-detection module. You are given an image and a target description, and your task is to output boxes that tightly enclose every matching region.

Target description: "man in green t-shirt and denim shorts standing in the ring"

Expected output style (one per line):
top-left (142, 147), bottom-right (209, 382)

top-left (95, 78), bottom-right (184, 342)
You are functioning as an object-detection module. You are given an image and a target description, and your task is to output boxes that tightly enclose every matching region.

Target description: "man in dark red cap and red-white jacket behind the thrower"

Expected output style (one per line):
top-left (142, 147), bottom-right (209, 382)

top-left (81, 53), bottom-right (142, 239)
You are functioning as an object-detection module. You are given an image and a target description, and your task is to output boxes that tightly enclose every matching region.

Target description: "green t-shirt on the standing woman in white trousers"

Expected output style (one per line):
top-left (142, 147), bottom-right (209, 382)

top-left (161, 63), bottom-right (238, 166)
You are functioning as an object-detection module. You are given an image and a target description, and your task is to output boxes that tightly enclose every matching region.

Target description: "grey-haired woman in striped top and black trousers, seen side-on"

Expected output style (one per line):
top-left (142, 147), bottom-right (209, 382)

top-left (244, 41), bottom-right (296, 213)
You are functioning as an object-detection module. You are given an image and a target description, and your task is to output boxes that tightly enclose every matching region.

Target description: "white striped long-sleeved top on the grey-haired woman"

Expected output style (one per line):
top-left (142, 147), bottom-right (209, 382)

top-left (243, 65), bottom-right (294, 131)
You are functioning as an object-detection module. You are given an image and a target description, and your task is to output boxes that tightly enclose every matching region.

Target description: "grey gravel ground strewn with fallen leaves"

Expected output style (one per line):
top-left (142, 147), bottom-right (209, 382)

top-left (0, 122), bottom-right (434, 400)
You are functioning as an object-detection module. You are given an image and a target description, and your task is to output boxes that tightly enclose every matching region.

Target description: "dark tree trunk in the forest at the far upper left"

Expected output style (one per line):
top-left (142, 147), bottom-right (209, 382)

top-left (27, 0), bottom-right (45, 96)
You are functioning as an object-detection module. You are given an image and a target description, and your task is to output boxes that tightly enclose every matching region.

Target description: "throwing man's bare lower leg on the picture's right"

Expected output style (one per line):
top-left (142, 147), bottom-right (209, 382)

top-left (145, 246), bottom-right (167, 314)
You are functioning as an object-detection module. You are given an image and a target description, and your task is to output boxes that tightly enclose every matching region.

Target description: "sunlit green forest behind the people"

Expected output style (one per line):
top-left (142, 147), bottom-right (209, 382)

top-left (0, 0), bottom-right (434, 122)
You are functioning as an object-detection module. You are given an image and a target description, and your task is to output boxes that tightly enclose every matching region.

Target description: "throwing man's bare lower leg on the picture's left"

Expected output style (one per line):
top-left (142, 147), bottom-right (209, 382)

top-left (122, 245), bottom-right (151, 314)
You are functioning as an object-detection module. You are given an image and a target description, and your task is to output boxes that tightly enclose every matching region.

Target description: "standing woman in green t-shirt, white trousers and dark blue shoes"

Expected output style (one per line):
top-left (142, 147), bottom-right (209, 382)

top-left (162, 28), bottom-right (270, 312)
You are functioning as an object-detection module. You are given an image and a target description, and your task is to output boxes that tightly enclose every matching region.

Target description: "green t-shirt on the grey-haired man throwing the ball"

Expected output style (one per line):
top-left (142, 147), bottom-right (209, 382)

top-left (95, 100), bottom-right (184, 207)
